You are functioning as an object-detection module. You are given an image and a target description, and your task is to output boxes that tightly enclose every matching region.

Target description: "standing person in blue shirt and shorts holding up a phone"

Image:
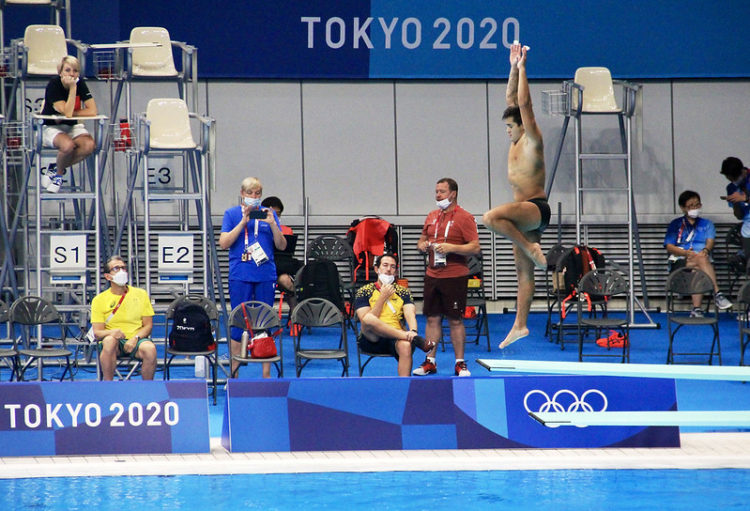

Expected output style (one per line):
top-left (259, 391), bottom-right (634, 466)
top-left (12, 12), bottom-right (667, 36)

top-left (219, 177), bottom-right (286, 378)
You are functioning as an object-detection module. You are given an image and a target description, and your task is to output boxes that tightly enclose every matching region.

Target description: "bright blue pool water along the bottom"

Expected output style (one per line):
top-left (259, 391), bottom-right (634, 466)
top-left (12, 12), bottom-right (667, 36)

top-left (0, 469), bottom-right (750, 511)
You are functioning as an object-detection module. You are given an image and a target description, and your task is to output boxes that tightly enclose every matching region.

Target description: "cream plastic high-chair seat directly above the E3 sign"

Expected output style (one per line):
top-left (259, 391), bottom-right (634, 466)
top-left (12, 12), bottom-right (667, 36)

top-left (146, 98), bottom-right (196, 149)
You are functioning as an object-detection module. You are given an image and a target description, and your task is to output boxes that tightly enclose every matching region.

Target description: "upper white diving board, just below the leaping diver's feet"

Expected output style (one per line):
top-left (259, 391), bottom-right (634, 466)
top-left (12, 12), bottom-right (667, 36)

top-left (477, 358), bottom-right (750, 381)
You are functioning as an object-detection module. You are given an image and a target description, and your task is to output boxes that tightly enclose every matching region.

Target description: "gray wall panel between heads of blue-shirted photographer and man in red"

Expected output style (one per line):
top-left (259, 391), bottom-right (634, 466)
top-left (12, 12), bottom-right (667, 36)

top-left (302, 82), bottom-right (397, 216)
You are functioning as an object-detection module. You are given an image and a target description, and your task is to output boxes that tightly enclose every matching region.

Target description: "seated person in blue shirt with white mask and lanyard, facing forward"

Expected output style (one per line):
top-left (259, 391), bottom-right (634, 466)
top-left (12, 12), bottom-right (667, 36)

top-left (664, 190), bottom-right (732, 317)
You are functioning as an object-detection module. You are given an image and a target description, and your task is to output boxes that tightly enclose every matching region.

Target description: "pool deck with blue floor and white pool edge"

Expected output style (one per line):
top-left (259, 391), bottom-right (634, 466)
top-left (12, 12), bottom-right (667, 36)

top-left (0, 313), bottom-right (750, 479)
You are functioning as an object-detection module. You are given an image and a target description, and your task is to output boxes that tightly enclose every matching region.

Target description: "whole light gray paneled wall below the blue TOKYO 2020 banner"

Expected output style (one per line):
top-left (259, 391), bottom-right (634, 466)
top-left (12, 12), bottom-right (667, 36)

top-left (85, 80), bottom-right (750, 225)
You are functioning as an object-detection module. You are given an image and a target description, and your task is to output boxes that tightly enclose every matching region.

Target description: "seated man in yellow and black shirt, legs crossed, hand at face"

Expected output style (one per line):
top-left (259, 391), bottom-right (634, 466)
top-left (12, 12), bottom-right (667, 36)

top-left (354, 254), bottom-right (435, 376)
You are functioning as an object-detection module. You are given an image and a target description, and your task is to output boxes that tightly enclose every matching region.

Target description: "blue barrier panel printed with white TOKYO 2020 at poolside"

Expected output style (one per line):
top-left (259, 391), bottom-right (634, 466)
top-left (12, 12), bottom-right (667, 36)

top-left (0, 381), bottom-right (210, 456)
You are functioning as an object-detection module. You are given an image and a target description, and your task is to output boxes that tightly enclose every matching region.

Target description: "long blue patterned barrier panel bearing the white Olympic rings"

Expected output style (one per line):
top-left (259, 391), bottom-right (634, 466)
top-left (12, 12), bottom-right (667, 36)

top-left (222, 376), bottom-right (679, 452)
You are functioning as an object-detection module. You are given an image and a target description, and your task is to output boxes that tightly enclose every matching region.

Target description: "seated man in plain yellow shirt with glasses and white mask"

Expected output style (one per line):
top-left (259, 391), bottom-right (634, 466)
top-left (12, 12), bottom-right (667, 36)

top-left (91, 255), bottom-right (156, 381)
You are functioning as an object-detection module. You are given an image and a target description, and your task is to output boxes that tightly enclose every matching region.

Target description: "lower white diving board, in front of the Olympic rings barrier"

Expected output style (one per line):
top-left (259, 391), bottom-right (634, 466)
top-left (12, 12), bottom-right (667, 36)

top-left (529, 410), bottom-right (750, 428)
